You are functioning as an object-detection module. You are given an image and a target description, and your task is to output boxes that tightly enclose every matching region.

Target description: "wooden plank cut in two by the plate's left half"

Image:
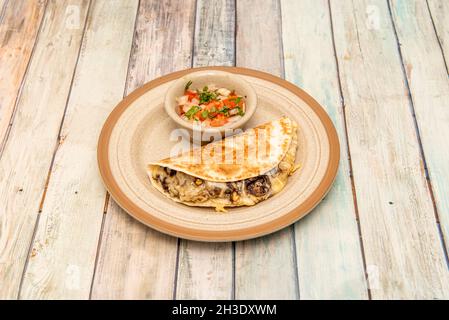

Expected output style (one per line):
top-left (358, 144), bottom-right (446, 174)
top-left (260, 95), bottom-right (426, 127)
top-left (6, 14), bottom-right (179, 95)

top-left (92, 0), bottom-right (195, 299)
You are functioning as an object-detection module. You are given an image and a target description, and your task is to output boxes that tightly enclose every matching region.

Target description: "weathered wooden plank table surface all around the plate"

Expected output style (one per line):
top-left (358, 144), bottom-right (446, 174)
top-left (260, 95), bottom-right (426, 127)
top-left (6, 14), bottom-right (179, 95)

top-left (0, 0), bottom-right (449, 299)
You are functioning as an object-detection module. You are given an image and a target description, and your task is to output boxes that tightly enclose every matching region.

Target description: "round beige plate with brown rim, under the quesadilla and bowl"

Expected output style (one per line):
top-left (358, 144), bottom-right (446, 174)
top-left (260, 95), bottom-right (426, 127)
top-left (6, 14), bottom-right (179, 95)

top-left (98, 67), bottom-right (340, 241)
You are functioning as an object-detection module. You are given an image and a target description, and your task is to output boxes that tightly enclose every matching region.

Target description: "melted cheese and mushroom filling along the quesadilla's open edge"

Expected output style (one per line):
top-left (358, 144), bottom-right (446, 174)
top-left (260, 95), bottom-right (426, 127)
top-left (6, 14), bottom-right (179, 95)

top-left (153, 166), bottom-right (281, 203)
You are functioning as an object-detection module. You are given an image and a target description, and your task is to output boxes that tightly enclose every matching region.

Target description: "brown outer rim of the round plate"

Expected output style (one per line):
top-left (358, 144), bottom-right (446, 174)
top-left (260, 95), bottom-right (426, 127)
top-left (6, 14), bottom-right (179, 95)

top-left (97, 67), bottom-right (340, 241)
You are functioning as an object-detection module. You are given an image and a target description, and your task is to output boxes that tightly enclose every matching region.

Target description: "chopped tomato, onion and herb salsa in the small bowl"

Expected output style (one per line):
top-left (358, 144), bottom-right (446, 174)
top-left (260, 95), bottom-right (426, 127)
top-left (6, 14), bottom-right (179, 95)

top-left (176, 81), bottom-right (245, 127)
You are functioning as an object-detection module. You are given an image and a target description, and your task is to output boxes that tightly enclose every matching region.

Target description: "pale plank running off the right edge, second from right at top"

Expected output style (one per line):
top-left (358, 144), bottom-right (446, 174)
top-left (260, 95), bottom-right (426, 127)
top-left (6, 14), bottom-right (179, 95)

top-left (391, 1), bottom-right (449, 270)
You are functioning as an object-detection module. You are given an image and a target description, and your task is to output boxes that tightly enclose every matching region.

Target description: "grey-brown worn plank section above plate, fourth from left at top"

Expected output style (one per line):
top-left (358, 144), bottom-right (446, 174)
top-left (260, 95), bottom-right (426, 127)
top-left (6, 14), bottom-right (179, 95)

top-left (126, 0), bottom-right (195, 93)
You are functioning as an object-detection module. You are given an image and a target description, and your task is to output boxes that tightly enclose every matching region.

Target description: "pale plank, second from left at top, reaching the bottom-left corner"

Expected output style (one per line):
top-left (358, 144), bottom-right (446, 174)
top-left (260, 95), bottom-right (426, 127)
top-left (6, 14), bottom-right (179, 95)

top-left (0, 1), bottom-right (88, 299)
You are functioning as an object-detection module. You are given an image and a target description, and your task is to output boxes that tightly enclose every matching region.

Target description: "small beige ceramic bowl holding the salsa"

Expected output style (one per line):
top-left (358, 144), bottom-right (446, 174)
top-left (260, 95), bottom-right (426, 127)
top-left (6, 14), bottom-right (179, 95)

top-left (164, 70), bottom-right (257, 143)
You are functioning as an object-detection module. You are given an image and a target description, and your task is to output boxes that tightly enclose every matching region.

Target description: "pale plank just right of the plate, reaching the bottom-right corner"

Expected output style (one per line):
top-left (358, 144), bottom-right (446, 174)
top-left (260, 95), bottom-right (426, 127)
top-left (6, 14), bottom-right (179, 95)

top-left (331, 0), bottom-right (449, 299)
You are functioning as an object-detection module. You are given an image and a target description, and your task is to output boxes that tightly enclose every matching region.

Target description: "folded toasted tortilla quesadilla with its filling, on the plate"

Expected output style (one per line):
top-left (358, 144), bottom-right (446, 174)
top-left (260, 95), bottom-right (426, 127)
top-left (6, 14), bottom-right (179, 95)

top-left (148, 117), bottom-right (297, 211)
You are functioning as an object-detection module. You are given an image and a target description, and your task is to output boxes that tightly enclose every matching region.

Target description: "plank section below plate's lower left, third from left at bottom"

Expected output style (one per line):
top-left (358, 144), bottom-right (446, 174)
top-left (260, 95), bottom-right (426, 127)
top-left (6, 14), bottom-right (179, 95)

top-left (91, 199), bottom-right (177, 299)
